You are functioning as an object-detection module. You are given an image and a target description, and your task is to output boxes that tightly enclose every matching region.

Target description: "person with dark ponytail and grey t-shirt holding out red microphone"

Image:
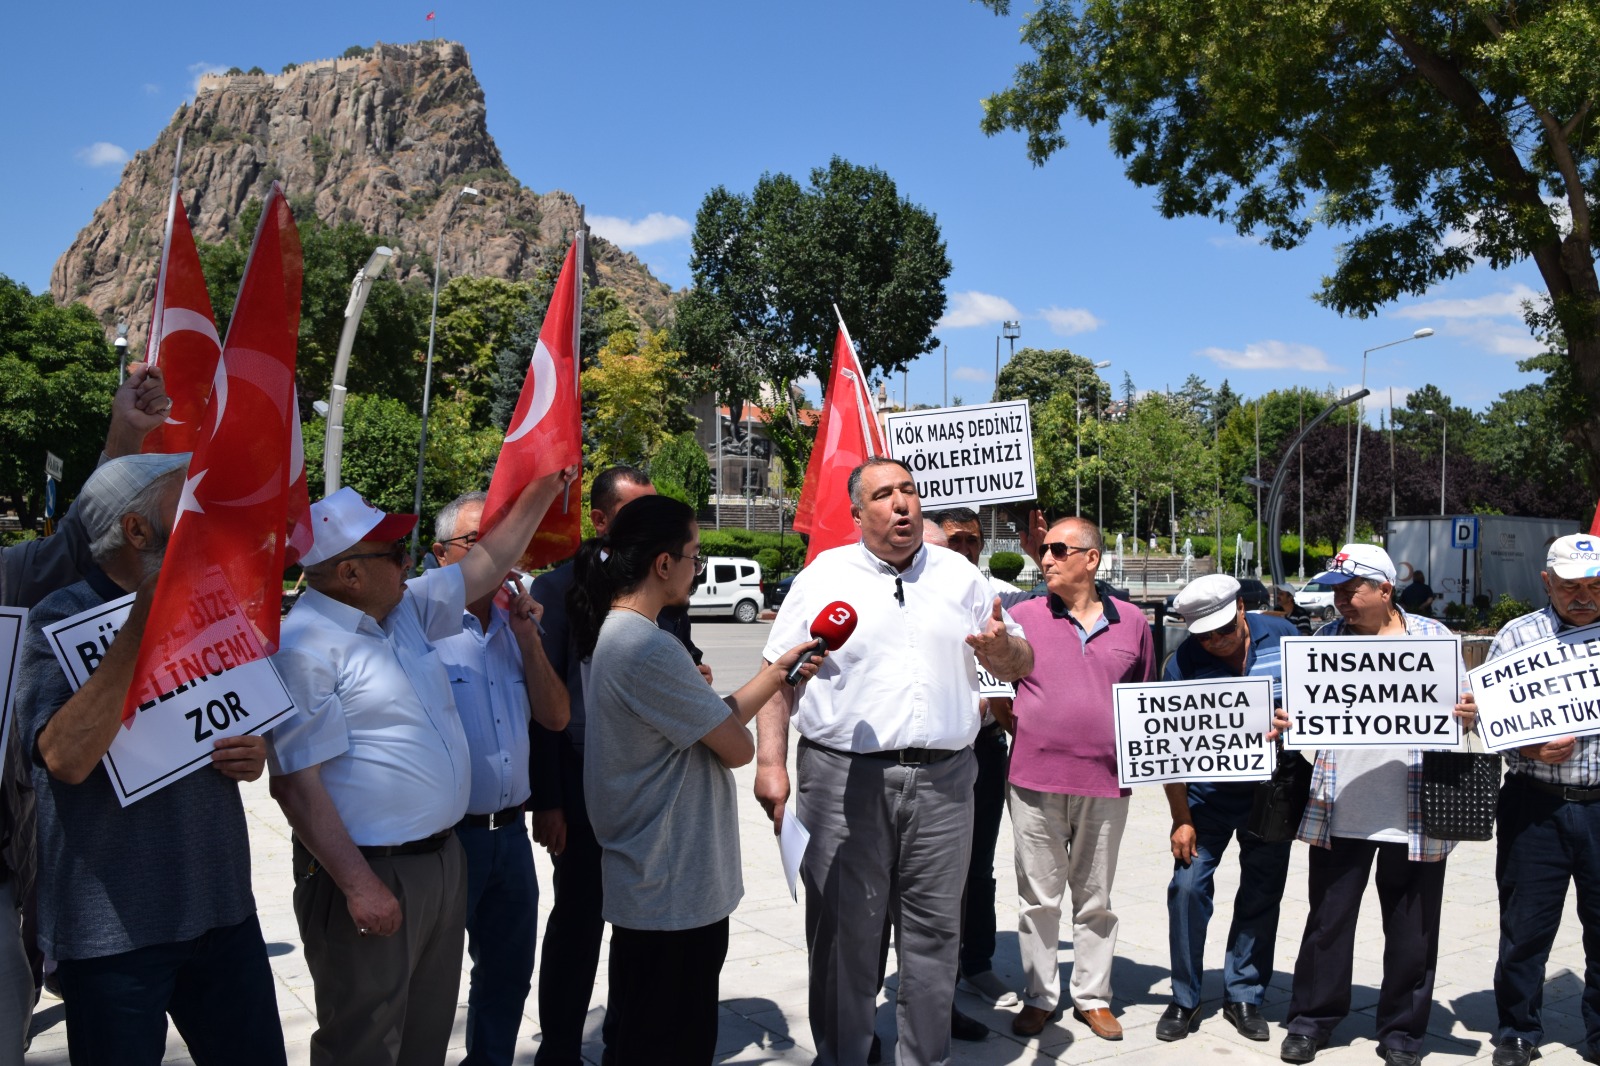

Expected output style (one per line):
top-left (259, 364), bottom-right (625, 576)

top-left (568, 496), bottom-right (821, 1066)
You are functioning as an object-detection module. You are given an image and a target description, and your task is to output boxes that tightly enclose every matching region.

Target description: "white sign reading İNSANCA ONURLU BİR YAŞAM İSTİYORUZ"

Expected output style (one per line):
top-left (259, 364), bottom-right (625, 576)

top-left (1110, 677), bottom-right (1277, 787)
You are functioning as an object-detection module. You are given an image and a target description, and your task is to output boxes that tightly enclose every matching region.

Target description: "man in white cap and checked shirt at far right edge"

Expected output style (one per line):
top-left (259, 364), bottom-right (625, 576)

top-left (1488, 535), bottom-right (1600, 1066)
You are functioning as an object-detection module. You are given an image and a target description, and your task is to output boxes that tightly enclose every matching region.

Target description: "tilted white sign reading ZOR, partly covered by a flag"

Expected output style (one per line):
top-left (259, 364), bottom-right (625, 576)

top-left (45, 594), bottom-right (294, 807)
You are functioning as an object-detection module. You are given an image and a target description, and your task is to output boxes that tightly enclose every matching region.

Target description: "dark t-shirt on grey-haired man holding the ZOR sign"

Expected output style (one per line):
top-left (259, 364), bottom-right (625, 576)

top-left (16, 570), bottom-right (256, 959)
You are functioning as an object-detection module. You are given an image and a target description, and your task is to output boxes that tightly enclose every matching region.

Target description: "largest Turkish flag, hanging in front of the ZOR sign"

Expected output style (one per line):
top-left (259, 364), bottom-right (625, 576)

top-left (123, 182), bottom-right (310, 725)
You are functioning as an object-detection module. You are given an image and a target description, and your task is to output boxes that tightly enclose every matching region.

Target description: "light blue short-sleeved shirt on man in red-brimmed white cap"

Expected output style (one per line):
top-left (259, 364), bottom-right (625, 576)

top-left (267, 567), bottom-right (472, 845)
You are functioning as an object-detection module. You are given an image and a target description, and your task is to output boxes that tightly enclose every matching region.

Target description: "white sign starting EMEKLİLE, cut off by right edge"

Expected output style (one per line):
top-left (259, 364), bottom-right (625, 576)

top-left (1467, 624), bottom-right (1600, 751)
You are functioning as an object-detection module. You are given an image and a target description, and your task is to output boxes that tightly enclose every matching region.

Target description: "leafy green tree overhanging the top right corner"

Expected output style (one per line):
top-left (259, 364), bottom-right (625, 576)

top-left (982, 0), bottom-right (1600, 483)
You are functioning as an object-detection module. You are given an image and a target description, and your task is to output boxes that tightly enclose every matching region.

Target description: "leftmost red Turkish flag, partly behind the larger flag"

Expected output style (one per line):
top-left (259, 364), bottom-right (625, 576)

top-left (142, 188), bottom-right (222, 455)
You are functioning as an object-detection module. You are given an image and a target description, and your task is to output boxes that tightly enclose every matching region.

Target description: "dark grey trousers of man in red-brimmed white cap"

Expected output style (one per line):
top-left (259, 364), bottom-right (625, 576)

top-left (294, 834), bottom-right (467, 1066)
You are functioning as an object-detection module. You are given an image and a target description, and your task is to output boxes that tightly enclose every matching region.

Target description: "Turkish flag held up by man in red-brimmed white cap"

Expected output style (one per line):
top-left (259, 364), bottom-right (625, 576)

top-left (478, 240), bottom-right (584, 570)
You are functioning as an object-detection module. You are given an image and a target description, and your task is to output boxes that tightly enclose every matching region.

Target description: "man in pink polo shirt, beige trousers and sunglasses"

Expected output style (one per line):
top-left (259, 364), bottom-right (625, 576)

top-left (1010, 519), bottom-right (1155, 1040)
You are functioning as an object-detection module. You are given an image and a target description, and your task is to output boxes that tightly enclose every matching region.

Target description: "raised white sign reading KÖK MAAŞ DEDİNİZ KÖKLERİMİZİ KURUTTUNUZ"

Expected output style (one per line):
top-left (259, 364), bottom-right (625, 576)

top-left (883, 400), bottom-right (1038, 512)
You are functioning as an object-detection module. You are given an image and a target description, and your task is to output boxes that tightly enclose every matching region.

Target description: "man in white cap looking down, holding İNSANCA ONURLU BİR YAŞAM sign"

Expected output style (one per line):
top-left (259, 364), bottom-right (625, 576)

top-left (1155, 573), bottom-right (1299, 1040)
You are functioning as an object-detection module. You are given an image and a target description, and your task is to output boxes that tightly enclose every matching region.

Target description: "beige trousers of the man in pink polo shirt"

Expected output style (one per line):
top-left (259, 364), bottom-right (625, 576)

top-left (1008, 784), bottom-right (1128, 1012)
